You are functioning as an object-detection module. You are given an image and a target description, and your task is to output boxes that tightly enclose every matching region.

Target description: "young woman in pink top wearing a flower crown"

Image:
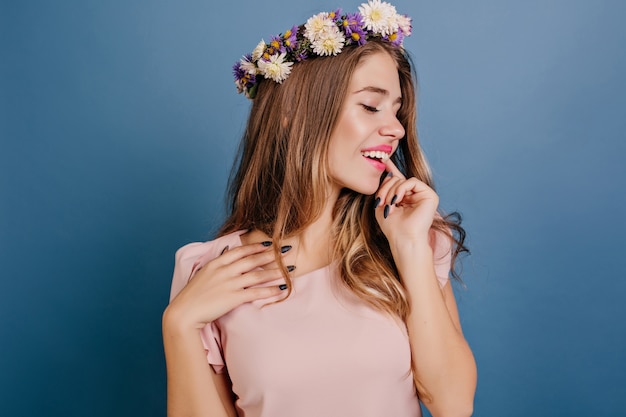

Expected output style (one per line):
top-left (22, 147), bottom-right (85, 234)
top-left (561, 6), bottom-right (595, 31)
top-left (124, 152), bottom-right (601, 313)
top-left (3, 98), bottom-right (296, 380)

top-left (163, 0), bottom-right (476, 417)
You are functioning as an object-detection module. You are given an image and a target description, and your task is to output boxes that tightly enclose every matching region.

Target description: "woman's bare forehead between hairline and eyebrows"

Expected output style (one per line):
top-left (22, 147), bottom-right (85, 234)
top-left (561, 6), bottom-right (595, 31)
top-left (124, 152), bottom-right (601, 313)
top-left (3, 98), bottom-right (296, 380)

top-left (349, 52), bottom-right (401, 96)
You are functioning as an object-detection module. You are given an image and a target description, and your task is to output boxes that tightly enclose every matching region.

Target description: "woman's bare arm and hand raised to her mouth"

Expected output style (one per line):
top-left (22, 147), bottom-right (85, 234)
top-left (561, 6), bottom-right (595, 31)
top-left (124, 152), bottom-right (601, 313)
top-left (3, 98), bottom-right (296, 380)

top-left (376, 161), bottom-right (476, 417)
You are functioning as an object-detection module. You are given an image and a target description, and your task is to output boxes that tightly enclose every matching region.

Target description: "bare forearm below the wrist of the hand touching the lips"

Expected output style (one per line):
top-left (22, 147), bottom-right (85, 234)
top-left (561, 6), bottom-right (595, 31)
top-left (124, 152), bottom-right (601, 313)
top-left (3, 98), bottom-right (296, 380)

top-left (392, 240), bottom-right (476, 416)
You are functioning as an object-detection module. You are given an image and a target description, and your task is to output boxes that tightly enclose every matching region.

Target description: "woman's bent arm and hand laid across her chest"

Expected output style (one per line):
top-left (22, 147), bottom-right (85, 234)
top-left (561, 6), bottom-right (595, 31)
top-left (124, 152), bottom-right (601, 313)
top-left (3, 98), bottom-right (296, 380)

top-left (163, 243), bottom-right (282, 417)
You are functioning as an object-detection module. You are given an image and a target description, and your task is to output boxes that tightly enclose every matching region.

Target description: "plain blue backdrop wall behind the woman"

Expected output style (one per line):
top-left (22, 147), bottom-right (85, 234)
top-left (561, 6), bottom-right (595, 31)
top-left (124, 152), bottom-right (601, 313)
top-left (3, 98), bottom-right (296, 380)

top-left (0, 0), bottom-right (626, 417)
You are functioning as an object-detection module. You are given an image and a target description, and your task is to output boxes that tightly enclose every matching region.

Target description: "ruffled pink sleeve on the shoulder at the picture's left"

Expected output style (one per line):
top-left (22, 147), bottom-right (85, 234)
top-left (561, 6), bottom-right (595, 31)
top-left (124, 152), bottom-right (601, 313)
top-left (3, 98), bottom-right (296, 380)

top-left (170, 238), bottom-right (236, 373)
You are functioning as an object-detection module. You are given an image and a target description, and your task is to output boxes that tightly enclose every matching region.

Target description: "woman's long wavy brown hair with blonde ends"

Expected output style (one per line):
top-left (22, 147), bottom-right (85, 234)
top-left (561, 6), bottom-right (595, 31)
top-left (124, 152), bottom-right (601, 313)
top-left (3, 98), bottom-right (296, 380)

top-left (219, 40), bottom-right (466, 320)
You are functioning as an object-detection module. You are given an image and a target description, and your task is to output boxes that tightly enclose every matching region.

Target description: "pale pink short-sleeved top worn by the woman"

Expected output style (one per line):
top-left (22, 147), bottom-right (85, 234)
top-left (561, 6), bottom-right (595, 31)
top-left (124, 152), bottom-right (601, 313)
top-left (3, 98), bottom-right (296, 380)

top-left (171, 232), bottom-right (450, 417)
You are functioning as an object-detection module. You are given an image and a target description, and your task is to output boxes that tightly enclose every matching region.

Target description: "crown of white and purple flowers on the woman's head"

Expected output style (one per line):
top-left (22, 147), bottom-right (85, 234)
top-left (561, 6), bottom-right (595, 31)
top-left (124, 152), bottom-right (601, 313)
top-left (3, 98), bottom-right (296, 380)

top-left (233, 0), bottom-right (411, 99)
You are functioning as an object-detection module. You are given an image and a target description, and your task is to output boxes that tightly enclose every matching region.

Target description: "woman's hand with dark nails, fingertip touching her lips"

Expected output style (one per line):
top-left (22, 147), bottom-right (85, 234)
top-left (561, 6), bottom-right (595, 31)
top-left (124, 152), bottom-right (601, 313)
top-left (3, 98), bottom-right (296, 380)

top-left (375, 159), bottom-right (439, 244)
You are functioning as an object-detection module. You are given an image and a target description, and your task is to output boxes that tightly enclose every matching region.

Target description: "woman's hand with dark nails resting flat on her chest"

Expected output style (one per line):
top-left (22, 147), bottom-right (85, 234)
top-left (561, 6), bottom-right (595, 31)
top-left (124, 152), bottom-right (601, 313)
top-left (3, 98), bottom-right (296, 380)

top-left (164, 243), bottom-right (282, 330)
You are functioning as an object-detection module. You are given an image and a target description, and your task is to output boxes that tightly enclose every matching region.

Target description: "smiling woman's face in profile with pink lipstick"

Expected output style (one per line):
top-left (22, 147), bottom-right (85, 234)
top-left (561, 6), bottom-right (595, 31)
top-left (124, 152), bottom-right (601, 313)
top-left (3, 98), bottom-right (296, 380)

top-left (328, 52), bottom-right (404, 194)
